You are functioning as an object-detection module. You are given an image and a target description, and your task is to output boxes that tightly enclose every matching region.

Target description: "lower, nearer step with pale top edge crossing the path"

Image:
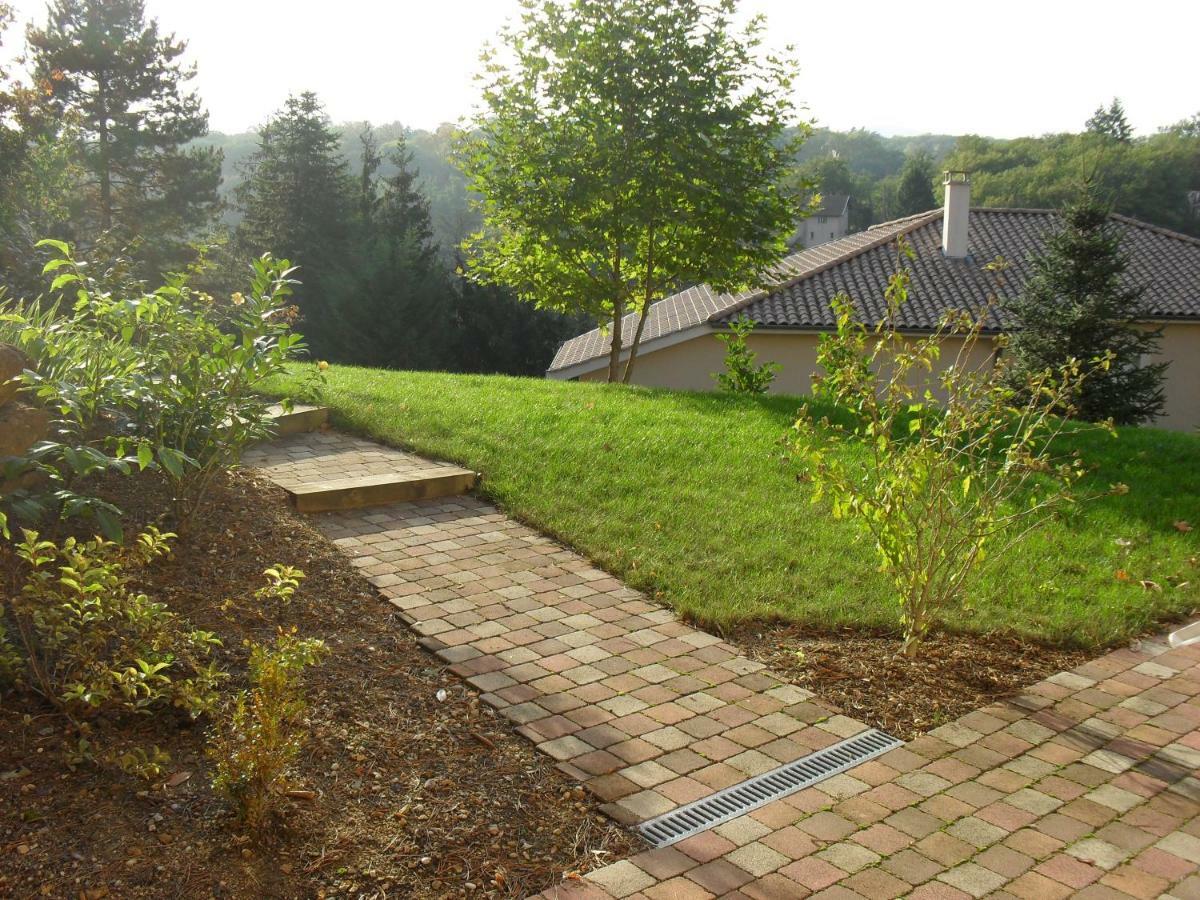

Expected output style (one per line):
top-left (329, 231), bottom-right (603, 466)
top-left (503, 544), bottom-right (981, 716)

top-left (284, 466), bottom-right (479, 512)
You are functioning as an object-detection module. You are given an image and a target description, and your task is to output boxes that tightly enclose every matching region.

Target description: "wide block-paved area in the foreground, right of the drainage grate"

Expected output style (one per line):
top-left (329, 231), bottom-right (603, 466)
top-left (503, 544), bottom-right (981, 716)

top-left (540, 628), bottom-right (1200, 900)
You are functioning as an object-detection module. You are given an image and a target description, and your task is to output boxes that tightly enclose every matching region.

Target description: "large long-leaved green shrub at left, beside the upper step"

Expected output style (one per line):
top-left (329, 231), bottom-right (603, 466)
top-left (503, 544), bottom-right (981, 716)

top-left (0, 241), bottom-right (304, 536)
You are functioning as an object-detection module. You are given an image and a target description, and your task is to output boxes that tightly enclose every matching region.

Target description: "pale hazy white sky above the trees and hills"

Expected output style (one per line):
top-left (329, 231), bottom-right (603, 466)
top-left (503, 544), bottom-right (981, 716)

top-left (6, 0), bottom-right (1200, 137)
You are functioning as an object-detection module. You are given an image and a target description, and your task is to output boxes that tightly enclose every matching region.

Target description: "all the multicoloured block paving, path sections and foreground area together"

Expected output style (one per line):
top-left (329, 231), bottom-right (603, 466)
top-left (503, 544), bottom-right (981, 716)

top-left (247, 433), bottom-right (1200, 900)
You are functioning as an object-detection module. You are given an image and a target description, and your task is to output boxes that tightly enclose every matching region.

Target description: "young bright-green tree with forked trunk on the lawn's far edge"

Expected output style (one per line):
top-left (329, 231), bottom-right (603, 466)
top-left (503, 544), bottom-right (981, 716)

top-left (460, 0), bottom-right (806, 382)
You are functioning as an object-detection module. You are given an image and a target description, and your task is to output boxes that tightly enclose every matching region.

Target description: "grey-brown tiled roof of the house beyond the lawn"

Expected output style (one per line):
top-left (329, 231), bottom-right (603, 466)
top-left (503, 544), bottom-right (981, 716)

top-left (550, 208), bottom-right (1200, 372)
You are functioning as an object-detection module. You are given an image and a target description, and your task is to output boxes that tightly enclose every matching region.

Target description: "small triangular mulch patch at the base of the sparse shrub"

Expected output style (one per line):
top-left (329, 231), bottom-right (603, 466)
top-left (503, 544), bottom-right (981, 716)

top-left (728, 624), bottom-right (1094, 740)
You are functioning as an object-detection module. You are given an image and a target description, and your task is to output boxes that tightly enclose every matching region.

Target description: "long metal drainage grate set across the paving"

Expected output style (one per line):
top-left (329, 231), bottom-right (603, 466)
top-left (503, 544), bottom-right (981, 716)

top-left (638, 728), bottom-right (904, 847)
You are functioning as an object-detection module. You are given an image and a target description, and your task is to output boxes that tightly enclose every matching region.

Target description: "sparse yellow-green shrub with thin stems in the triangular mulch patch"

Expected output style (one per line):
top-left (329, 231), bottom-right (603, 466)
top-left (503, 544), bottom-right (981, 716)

top-left (793, 250), bottom-right (1108, 655)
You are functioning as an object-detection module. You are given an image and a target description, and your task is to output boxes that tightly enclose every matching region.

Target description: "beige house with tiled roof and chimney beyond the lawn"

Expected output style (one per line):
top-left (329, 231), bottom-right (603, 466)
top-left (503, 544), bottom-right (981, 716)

top-left (547, 173), bottom-right (1200, 430)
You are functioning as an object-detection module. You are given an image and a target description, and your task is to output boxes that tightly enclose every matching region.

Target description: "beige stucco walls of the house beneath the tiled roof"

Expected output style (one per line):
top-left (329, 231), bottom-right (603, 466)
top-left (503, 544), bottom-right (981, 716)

top-left (581, 323), bottom-right (1200, 431)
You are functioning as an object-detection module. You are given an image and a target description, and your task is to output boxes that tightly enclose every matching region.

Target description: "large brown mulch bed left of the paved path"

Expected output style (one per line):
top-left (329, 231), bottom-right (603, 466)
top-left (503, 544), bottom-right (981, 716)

top-left (0, 473), bottom-right (641, 898)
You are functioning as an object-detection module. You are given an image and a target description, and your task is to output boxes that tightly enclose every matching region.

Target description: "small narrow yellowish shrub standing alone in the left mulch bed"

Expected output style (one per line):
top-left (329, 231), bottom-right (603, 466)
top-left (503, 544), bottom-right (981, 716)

top-left (208, 632), bottom-right (326, 830)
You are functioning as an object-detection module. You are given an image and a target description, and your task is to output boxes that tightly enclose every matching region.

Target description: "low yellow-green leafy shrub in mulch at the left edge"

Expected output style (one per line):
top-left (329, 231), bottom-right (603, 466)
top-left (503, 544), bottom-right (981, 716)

top-left (0, 528), bottom-right (224, 768)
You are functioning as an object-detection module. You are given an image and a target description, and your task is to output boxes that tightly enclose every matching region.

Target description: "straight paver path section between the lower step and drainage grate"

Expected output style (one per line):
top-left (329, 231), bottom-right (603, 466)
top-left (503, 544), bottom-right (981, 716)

top-left (317, 497), bottom-right (866, 823)
